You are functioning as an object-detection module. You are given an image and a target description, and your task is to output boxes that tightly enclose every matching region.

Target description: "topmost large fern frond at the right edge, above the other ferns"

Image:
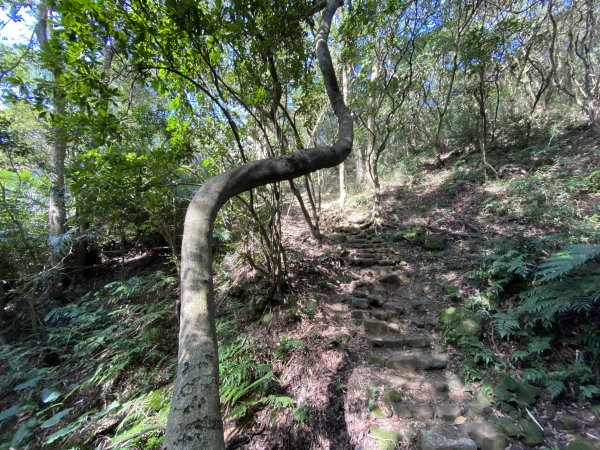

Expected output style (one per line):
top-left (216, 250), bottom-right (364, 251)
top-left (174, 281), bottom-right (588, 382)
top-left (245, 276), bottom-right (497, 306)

top-left (536, 244), bottom-right (600, 283)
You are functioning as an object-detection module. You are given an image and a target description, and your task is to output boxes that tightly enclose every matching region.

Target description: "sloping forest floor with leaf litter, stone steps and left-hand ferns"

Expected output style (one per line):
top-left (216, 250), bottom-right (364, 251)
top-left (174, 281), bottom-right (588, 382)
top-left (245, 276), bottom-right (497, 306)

top-left (0, 127), bottom-right (600, 450)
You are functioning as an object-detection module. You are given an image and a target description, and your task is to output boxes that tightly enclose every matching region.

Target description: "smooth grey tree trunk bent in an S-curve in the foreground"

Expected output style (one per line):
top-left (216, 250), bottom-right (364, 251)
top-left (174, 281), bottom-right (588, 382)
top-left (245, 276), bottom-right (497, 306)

top-left (165, 0), bottom-right (353, 450)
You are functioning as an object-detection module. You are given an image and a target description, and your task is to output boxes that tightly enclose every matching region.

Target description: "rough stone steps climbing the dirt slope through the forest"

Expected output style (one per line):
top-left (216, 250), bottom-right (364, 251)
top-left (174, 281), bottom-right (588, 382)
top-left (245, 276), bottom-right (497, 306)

top-left (332, 227), bottom-right (508, 450)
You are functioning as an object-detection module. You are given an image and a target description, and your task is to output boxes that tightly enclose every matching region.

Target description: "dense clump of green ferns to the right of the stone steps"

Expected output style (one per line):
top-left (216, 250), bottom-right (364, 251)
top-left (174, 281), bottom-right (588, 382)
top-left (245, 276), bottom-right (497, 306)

top-left (445, 243), bottom-right (600, 406)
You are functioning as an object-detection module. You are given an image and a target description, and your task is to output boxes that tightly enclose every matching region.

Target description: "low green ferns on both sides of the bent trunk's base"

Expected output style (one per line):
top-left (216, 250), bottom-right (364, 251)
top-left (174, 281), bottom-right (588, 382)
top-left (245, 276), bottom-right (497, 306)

top-left (0, 271), bottom-right (306, 450)
